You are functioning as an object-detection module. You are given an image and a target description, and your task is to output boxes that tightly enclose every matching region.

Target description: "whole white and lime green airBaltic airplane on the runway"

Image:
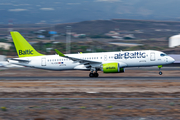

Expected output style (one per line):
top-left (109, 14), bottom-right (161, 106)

top-left (8, 31), bottom-right (175, 77)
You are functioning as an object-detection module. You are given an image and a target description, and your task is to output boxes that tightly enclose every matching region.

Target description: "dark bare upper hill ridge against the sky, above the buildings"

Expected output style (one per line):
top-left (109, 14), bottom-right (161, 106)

top-left (55, 19), bottom-right (180, 39)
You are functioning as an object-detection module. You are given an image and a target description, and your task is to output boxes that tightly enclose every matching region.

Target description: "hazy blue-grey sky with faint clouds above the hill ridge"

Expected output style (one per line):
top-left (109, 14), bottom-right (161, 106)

top-left (0, 0), bottom-right (180, 24)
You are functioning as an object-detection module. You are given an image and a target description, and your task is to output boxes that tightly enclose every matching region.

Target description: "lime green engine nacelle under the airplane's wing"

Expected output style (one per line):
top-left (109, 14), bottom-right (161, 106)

top-left (102, 63), bottom-right (125, 73)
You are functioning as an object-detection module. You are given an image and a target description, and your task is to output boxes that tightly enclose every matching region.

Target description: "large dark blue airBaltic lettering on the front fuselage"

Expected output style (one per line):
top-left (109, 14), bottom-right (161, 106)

top-left (114, 52), bottom-right (146, 59)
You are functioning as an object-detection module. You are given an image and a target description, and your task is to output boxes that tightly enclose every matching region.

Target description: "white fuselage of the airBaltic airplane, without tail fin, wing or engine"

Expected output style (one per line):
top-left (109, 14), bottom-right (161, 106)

top-left (9, 50), bottom-right (174, 70)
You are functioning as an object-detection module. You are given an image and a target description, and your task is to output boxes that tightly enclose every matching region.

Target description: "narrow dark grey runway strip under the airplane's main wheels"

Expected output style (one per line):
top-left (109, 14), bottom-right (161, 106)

top-left (0, 76), bottom-right (180, 81)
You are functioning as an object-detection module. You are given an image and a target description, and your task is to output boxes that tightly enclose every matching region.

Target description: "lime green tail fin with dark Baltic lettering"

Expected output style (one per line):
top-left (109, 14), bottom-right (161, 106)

top-left (11, 31), bottom-right (43, 57)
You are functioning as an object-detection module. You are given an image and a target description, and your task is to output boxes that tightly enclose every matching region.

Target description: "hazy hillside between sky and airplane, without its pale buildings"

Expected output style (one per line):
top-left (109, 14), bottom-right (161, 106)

top-left (0, 19), bottom-right (180, 55)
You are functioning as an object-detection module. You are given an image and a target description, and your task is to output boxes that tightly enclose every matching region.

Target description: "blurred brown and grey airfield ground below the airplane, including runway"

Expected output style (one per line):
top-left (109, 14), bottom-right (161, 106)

top-left (0, 67), bottom-right (180, 120)
